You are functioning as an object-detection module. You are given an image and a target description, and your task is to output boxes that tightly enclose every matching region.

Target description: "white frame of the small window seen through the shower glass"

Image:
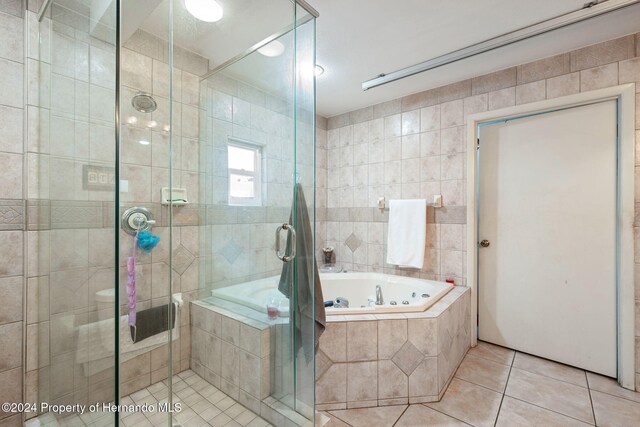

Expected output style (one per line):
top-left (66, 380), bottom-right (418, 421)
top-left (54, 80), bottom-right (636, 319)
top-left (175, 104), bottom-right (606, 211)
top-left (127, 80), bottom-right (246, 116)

top-left (227, 136), bottom-right (264, 206)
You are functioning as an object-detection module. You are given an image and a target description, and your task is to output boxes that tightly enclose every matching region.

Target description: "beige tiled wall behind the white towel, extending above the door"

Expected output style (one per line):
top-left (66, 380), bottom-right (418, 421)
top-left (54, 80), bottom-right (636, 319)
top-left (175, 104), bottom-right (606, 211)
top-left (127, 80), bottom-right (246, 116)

top-left (319, 34), bottom-right (640, 388)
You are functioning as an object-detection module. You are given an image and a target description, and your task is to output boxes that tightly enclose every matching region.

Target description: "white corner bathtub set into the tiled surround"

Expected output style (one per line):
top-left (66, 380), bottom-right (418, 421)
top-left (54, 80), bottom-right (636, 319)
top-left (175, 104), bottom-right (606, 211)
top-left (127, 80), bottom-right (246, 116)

top-left (211, 273), bottom-right (453, 317)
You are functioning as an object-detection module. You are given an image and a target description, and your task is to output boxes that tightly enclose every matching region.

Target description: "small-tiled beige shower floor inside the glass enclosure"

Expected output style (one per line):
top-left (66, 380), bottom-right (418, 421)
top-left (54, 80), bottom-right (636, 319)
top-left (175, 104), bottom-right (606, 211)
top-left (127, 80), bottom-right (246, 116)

top-left (25, 370), bottom-right (272, 427)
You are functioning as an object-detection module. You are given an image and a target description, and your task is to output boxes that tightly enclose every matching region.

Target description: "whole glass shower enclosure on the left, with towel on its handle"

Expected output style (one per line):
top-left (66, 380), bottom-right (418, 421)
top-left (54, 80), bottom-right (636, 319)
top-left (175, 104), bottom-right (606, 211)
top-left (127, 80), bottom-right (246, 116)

top-left (25, 0), bottom-right (317, 426)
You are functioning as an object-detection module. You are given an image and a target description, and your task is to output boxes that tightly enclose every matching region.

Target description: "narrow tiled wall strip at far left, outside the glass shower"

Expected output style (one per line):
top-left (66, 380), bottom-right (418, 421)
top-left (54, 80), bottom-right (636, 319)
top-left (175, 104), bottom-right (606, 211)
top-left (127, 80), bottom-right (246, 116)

top-left (0, 0), bottom-right (26, 426)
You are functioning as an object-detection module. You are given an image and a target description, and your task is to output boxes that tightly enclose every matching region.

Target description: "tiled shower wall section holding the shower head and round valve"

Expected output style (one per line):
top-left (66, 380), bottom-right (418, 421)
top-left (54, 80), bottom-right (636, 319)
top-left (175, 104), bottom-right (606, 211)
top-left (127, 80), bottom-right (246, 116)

top-left (115, 30), bottom-right (209, 394)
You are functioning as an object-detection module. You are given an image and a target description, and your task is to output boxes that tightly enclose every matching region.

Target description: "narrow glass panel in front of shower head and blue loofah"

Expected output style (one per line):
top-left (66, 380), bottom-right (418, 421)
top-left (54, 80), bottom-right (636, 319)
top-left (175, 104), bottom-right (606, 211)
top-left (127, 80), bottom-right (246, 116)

top-left (119, 1), bottom-right (175, 425)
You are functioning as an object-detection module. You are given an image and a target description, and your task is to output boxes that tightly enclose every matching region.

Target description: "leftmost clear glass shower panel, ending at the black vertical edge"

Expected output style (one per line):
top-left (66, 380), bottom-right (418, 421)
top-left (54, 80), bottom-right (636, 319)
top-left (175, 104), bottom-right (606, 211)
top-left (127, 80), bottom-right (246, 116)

top-left (31, 0), bottom-right (117, 425)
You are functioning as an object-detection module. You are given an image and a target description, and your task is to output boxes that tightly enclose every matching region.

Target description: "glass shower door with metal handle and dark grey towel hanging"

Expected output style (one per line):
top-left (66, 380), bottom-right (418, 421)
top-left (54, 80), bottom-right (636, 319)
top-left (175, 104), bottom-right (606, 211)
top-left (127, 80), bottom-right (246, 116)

top-left (199, 3), bottom-right (315, 425)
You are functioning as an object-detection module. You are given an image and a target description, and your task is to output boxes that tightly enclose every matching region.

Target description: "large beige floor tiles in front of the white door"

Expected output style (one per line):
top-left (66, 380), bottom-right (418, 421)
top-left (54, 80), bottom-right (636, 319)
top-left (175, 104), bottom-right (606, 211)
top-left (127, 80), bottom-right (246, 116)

top-left (327, 342), bottom-right (640, 427)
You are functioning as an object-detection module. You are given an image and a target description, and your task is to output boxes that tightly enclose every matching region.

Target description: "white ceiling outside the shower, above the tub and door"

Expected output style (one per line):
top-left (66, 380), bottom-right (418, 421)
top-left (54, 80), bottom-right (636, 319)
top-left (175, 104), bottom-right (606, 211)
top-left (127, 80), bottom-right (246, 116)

top-left (311, 0), bottom-right (640, 117)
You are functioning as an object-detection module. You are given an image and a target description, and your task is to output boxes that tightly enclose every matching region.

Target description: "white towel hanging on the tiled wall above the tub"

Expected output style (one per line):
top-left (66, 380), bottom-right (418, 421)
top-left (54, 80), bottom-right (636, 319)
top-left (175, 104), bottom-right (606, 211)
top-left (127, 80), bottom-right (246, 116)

top-left (387, 199), bottom-right (427, 268)
